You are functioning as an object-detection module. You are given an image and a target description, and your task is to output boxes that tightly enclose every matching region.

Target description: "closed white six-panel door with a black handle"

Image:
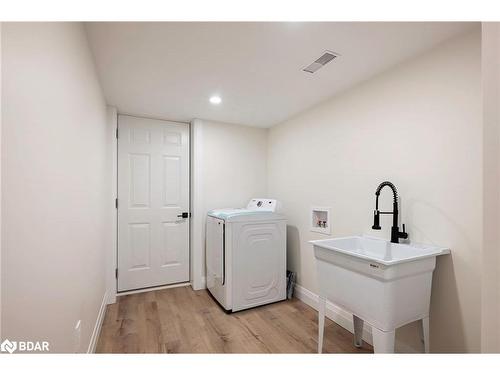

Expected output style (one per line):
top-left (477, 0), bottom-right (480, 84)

top-left (118, 115), bottom-right (189, 291)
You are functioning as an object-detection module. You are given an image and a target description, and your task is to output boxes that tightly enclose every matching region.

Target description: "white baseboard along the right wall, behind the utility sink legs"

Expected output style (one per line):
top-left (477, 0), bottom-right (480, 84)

top-left (295, 285), bottom-right (419, 353)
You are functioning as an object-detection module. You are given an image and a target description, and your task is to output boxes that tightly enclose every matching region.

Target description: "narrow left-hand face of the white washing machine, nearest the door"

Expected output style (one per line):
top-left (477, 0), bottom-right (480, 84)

top-left (206, 216), bottom-right (230, 309)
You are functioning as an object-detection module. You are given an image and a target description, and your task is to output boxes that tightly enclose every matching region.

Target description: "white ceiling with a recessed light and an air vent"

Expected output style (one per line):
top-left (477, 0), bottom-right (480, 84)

top-left (86, 22), bottom-right (477, 127)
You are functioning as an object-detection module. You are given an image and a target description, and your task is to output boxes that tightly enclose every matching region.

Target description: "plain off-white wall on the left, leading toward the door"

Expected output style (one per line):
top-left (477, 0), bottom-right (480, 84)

top-left (1, 23), bottom-right (112, 352)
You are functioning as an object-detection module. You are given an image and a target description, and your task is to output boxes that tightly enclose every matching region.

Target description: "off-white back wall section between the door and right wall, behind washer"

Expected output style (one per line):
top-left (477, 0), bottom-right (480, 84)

top-left (191, 120), bottom-right (268, 289)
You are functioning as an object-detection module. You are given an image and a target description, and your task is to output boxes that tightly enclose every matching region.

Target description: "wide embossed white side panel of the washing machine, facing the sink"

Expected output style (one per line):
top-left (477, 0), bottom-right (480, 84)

top-left (232, 220), bottom-right (286, 311)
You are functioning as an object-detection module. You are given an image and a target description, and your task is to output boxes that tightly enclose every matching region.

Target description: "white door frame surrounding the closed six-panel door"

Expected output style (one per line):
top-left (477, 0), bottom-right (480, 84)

top-left (106, 106), bottom-right (193, 304)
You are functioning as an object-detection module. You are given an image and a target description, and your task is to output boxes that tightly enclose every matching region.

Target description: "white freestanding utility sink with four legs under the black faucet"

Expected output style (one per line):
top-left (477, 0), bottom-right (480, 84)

top-left (310, 236), bottom-right (450, 353)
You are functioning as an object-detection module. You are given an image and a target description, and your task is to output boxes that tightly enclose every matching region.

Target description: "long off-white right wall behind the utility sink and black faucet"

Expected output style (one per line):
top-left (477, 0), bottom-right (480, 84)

top-left (268, 29), bottom-right (483, 352)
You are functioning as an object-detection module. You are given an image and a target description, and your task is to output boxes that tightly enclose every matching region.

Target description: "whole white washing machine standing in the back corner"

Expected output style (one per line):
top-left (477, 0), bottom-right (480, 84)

top-left (206, 198), bottom-right (286, 312)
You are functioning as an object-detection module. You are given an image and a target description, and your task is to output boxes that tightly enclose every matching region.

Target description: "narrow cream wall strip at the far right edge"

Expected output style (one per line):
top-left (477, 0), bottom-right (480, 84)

top-left (481, 22), bottom-right (500, 353)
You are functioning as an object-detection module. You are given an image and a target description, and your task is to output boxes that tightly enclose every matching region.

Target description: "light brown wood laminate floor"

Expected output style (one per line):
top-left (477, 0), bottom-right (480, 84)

top-left (96, 286), bottom-right (372, 353)
